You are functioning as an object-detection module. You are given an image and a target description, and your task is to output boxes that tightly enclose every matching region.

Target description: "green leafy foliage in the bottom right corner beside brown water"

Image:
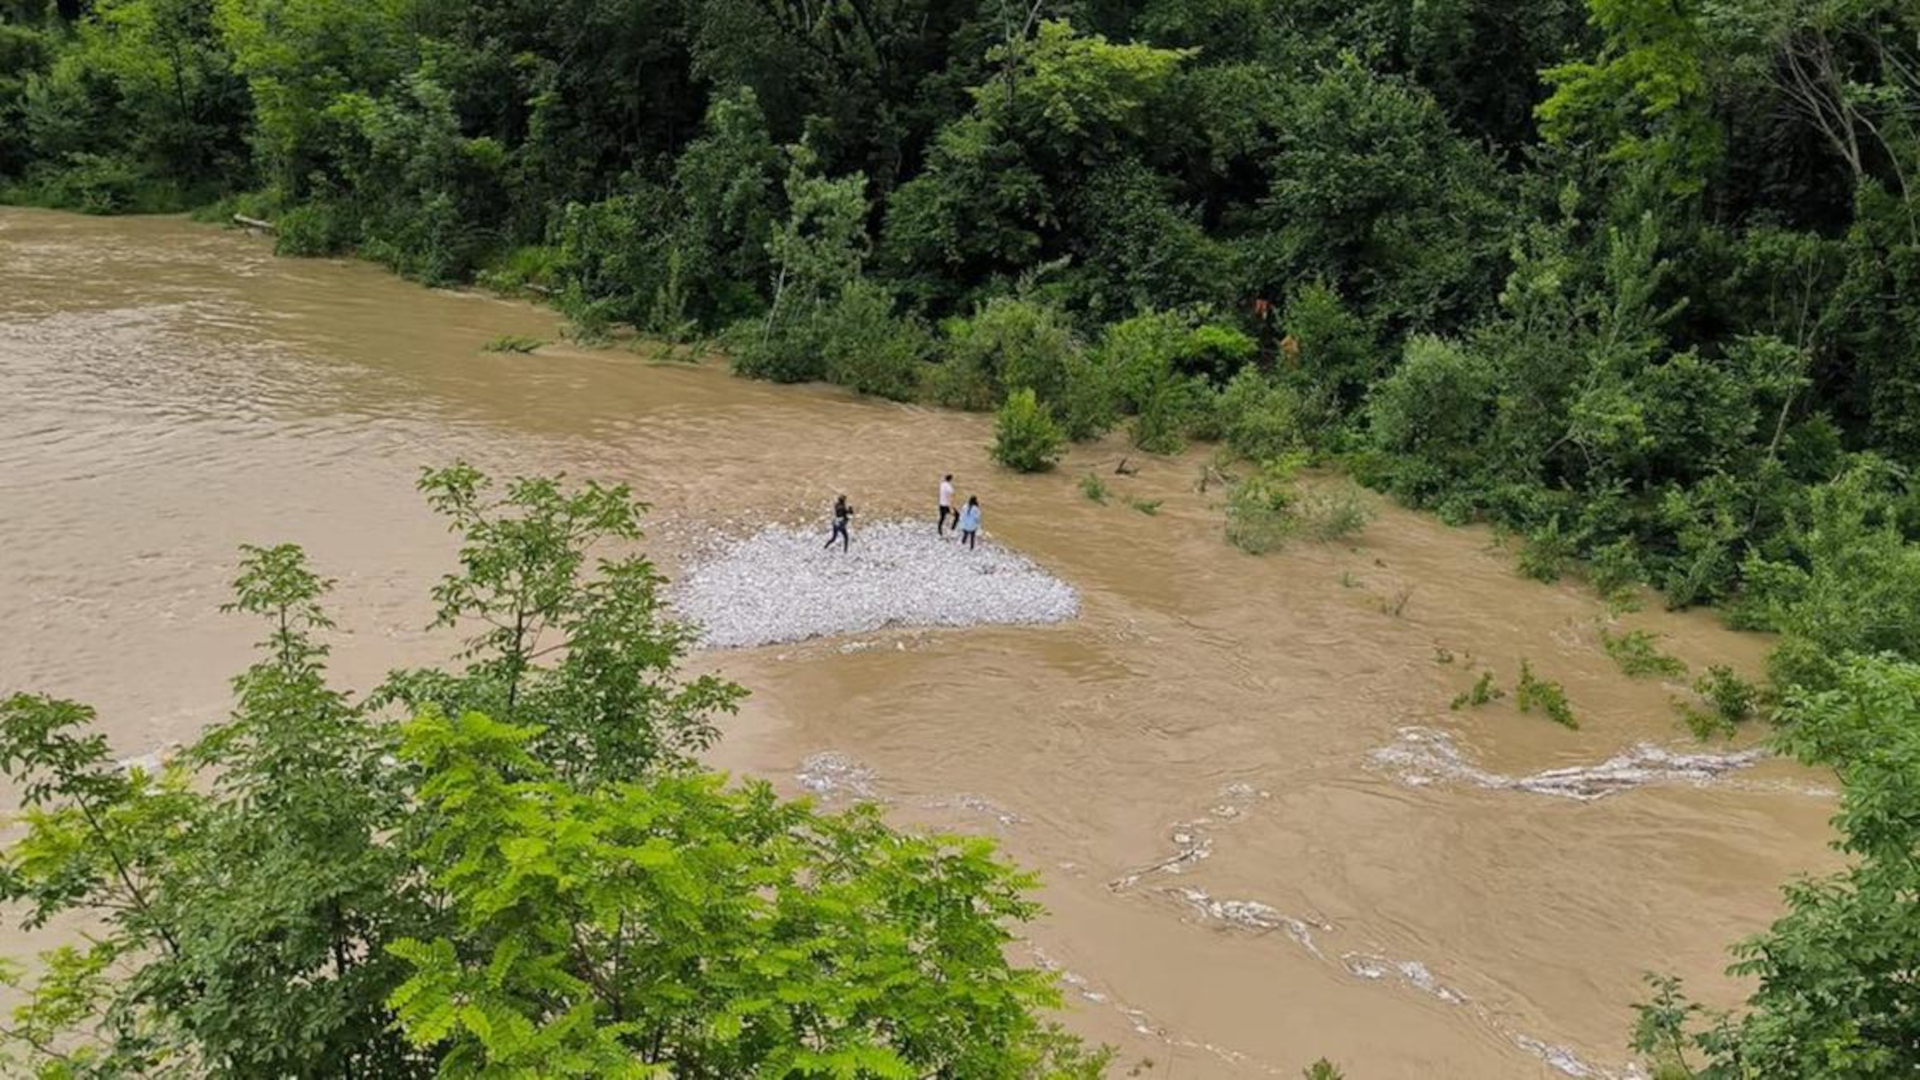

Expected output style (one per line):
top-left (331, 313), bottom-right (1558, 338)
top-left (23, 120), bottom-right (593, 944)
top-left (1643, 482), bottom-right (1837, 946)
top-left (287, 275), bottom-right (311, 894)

top-left (1634, 657), bottom-right (1920, 1080)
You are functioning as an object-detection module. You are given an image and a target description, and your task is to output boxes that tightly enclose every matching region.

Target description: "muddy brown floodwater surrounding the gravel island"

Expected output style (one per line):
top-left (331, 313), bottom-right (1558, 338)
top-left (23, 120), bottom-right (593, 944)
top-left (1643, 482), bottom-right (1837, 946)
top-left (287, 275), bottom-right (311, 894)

top-left (0, 209), bottom-right (1834, 1080)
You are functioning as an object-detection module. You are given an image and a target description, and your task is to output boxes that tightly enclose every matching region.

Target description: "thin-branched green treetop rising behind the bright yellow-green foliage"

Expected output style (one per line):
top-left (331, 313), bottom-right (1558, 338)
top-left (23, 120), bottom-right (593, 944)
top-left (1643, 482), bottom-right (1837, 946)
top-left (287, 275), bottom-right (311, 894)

top-left (376, 463), bottom-right (745, 784)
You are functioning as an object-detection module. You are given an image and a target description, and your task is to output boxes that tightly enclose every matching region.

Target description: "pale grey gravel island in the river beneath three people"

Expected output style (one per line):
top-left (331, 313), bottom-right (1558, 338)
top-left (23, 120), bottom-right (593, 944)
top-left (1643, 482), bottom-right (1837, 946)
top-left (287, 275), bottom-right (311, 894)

top-left (670, 521), bottom-right (1079, 650)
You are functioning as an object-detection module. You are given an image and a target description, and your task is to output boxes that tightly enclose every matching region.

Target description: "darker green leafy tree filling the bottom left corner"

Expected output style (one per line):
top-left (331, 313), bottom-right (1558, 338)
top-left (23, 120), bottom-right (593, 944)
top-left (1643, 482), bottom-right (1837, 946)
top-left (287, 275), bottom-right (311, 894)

top-left (0, 546), bottom-right (434, 1076)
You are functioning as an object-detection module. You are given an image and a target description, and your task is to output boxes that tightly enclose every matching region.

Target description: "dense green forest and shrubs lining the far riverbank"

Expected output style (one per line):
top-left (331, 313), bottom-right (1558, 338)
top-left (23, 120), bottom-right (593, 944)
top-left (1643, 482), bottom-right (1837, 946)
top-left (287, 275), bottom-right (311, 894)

top-left (0, 0), bottom-right (1920, 1076)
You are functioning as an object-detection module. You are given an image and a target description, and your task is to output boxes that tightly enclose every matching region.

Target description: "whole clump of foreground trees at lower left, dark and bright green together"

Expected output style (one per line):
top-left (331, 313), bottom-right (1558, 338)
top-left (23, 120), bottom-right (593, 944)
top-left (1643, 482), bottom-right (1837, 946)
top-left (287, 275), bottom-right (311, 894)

top-left (0, 465), bottom-right (1106, 1080)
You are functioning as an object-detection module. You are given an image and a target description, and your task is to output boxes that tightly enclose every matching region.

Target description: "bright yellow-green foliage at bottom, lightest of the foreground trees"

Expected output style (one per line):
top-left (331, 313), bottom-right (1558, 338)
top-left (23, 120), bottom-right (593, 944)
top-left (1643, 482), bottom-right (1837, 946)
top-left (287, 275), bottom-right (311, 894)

top-left (390, 713), bottom-right (1092, 1076)
